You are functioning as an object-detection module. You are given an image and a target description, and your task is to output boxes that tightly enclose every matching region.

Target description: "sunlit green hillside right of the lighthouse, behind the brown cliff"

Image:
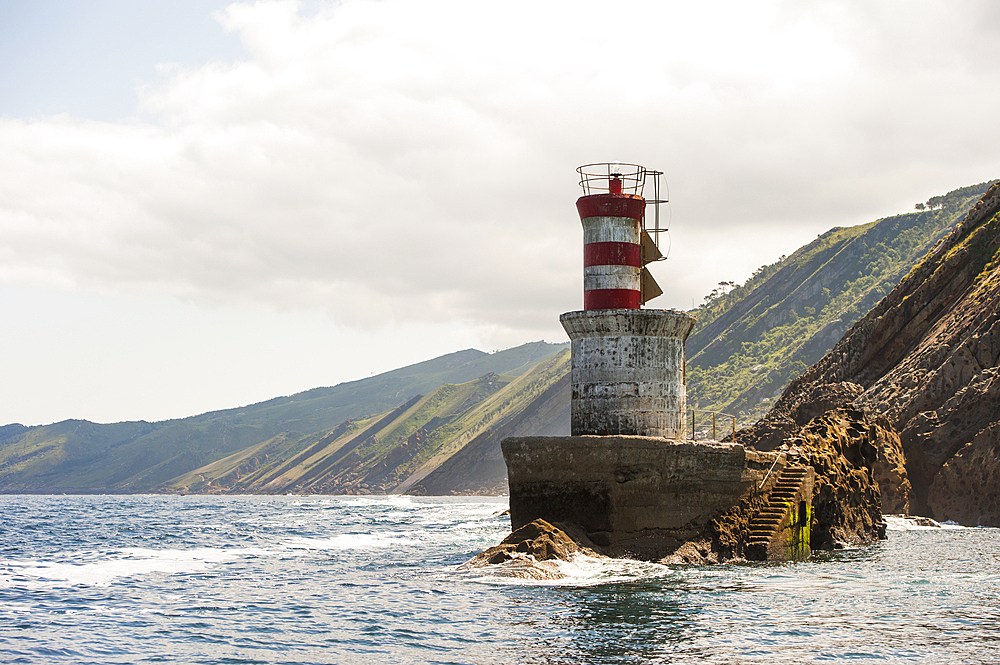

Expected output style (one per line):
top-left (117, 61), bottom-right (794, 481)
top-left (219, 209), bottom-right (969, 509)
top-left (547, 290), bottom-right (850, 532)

top-left (687, 183), bottom-right (991, 420)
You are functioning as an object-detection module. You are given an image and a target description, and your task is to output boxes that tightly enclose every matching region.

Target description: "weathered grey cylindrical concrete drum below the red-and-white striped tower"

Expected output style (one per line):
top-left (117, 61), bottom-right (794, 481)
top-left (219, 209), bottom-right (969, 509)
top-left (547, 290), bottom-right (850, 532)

top-left (559, 309), bottom-right (695, 439)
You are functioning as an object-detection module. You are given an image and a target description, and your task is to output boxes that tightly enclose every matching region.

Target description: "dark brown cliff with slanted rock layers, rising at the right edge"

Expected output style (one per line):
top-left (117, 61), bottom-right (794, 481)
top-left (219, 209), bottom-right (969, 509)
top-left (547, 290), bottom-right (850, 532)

top-left (736, 184), bottom-right (1000, 526)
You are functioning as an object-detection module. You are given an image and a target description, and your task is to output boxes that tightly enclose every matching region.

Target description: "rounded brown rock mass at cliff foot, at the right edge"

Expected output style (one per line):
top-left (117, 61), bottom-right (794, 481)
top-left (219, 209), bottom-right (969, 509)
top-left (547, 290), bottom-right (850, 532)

top-left (927, 423), bottom-right (1000, 527)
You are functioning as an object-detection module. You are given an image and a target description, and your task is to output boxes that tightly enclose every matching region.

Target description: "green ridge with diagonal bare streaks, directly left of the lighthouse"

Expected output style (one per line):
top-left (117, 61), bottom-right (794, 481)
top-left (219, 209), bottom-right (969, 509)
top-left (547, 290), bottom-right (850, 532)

top-left (163, 350), bottom-right (569, 494)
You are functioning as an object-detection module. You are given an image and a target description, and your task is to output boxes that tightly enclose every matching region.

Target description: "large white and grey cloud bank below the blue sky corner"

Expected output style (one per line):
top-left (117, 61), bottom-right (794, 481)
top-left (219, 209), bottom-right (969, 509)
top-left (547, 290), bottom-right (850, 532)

top-left (0, 0), bottom-right (1000, 344)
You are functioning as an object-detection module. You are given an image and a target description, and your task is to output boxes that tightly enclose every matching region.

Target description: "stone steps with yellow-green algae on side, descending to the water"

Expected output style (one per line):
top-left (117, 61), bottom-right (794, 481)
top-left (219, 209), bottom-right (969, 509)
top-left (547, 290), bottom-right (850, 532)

top-left (744, 466), bottom-right (815, 561)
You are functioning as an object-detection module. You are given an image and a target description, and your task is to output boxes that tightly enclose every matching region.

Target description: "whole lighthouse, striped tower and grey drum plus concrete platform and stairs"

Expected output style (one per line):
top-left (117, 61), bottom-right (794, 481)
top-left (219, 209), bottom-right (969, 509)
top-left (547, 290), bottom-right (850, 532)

top-left (500, 162), bottom-right (812, 561)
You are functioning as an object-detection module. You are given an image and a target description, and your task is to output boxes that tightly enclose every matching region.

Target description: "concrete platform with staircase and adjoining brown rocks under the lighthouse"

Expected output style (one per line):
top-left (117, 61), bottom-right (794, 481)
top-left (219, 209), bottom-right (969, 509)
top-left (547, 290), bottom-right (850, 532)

top-left (480, 430), bottom-right (885, 574)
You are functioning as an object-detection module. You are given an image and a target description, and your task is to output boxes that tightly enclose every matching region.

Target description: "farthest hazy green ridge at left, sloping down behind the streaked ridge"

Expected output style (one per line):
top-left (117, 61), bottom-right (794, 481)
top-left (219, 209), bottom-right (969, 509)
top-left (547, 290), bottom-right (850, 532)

top-left (0, 342), bottom-right (566, 492)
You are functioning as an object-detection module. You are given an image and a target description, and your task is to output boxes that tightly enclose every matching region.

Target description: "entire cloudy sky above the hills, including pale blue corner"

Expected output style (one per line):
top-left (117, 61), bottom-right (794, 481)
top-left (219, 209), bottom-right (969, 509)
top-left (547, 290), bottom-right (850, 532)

top-left (0, 0), bottom-right (1000, 425)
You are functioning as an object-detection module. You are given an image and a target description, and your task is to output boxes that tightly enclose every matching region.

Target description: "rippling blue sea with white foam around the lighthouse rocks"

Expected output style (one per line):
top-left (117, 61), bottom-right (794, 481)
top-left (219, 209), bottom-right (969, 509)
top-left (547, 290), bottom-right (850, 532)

top-left (0, 495), bottom-right (1000, 664)
